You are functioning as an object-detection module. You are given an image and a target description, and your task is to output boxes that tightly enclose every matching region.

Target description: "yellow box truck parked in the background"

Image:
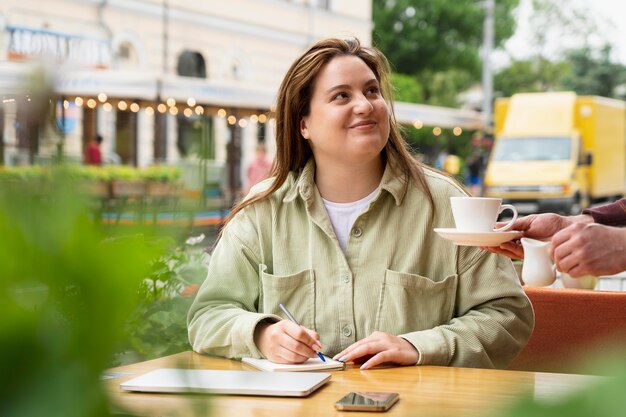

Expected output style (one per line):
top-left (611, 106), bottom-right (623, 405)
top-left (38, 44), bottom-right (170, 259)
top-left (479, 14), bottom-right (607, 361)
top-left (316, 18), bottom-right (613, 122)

top-left (483, 92), bottom-right (626, 214)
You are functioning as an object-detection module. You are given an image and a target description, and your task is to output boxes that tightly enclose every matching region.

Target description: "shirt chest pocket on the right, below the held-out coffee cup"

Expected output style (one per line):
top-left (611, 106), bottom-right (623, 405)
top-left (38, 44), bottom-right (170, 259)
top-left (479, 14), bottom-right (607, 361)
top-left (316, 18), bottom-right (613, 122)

top-left (376, 270), bottom-right (458, 335)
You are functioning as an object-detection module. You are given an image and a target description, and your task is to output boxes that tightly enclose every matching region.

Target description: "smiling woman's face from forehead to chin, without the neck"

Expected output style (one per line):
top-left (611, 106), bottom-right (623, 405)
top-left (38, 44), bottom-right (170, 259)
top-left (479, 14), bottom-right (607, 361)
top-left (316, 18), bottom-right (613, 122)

top-left (300, 56), bottom-right (389, 166)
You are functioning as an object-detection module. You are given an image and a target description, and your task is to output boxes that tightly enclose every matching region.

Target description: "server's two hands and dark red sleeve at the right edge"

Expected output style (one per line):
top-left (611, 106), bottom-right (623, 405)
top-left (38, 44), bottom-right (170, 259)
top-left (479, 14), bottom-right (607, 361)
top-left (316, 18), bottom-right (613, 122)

top-left (483, 198), bottom-right (626, 277)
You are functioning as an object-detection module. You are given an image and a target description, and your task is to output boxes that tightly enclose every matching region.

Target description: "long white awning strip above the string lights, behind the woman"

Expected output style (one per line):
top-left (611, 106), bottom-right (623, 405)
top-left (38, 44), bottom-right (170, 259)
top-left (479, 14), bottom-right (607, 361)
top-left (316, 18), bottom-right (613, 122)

top-left (0, 62), bottom-right (484, 130)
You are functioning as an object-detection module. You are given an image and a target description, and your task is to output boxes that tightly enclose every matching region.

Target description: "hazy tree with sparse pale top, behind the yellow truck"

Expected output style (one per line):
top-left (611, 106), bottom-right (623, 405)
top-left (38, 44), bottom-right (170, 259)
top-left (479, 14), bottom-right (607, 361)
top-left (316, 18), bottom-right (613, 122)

top-left (494, 0), bottom-right (626, 97)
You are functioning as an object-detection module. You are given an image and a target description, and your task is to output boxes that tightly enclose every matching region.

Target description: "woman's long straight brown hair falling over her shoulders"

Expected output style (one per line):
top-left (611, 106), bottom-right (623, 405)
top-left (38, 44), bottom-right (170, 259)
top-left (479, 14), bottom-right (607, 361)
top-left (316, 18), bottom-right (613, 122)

top-left (226, 39), bottom-right (434, 229)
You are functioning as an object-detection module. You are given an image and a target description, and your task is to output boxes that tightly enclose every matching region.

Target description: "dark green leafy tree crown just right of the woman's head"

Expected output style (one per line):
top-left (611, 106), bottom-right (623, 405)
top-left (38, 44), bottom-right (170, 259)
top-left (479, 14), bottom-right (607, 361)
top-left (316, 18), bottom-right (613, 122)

top-left (373, 0), bottom-right (519, 79)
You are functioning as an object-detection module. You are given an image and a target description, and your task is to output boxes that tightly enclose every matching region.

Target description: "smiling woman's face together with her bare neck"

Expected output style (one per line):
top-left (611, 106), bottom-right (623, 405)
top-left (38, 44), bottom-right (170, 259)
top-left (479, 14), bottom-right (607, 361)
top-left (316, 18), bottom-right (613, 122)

top-left (300, 56), bottom-right (389, 203)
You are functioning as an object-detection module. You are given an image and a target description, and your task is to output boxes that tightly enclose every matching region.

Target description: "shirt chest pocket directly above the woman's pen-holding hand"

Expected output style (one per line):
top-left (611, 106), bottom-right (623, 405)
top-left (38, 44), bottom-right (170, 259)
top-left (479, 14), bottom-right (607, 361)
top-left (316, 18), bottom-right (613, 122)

top-left (259, 265), bottom-right (315, 329)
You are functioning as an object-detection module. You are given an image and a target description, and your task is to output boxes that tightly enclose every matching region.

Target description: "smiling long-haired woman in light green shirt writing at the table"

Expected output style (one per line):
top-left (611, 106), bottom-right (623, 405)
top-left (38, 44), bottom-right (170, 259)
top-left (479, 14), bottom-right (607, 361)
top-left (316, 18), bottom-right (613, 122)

top-left (187, 35), bottom-right (534, 369)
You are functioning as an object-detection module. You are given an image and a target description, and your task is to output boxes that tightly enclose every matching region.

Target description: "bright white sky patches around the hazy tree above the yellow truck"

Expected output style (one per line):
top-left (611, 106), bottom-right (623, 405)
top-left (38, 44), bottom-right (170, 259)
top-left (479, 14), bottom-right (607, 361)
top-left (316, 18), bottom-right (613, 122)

top-left (493, 0), bottom-right (626, 67)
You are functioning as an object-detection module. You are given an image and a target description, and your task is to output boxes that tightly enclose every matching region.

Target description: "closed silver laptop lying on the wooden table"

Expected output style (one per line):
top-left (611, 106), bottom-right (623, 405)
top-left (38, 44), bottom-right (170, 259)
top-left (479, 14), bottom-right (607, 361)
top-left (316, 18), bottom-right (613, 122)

top-left (120, 368), bottom-right (331, 397)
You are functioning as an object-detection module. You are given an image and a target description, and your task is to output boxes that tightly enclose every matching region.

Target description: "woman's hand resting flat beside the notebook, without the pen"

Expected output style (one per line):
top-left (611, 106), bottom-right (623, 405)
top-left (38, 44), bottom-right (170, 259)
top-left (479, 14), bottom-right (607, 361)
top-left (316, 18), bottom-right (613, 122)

top-left (333, 332), bottom-right (419, 369)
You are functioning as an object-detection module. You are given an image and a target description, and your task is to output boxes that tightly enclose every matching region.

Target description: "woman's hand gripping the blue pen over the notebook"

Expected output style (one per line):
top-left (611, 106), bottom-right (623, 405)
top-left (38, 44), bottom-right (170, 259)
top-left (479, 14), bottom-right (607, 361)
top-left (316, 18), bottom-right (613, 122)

top-left (254, 320), bottom-right (322, 363)
